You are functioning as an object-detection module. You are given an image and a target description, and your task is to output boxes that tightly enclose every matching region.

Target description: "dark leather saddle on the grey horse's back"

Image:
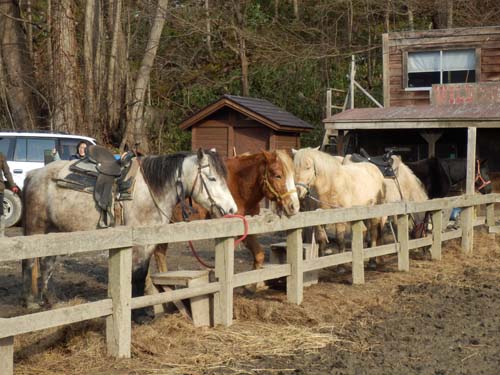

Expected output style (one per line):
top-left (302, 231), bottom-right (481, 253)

top-left (57, 146), bottom-right (138, 228)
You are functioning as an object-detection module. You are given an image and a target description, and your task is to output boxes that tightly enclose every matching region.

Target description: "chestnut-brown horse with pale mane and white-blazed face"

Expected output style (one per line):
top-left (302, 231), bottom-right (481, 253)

top-left (155, 150), bottom-right (300, 288)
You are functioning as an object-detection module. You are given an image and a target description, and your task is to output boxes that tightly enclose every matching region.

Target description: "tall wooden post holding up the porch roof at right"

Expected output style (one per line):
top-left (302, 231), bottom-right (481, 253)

top-left (461, 127), bottom-right (477, 255)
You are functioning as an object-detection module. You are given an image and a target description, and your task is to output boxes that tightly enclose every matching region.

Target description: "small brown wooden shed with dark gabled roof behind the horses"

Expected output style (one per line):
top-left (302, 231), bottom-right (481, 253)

top-left (179, 95), bottom-right (313, 157)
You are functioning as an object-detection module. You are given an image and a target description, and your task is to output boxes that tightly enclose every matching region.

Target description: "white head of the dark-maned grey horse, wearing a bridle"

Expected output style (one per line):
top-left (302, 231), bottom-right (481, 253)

top-left (182, 148), bottom-right (238, 217)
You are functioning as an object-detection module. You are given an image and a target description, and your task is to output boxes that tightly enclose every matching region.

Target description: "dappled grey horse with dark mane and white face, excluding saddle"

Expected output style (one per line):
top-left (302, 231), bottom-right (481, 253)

top-left (23, 149), bottom-right (237, 317)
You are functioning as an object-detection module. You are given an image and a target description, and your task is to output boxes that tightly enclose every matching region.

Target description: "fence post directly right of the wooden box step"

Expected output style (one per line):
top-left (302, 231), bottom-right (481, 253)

top-left (214, 237), bottom-right (234, 327)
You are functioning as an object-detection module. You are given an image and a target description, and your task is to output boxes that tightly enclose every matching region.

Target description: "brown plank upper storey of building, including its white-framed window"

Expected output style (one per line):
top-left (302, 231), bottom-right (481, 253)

top-left (382, 26), bottom-right (500, 107)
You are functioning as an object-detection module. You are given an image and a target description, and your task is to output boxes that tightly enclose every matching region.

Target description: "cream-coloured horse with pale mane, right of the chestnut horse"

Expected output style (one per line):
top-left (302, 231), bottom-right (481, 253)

top-left (294, 148), bottom-right (385, 258)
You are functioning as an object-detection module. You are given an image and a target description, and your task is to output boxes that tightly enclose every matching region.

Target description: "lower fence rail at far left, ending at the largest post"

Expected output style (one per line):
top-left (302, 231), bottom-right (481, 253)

top-left (0, 299), bottom-right (113, 338)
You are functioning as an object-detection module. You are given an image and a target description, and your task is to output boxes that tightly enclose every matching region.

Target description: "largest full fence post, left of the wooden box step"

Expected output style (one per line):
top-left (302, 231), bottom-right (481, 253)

top-left (106, 247), bottom-right (132, 358)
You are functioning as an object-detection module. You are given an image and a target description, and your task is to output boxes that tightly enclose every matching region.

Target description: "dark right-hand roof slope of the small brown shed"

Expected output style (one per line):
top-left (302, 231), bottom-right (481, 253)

top-left (223, 95), bottom-right (313, 129)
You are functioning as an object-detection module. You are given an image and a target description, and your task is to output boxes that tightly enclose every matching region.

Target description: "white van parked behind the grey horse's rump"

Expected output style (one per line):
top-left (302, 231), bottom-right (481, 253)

top-left (0, 131), bottom-right (96, 227)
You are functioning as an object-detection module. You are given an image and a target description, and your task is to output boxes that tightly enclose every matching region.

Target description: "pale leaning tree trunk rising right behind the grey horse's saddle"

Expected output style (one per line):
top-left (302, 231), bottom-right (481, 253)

top-left (120, 0), bottom-right (168, 153)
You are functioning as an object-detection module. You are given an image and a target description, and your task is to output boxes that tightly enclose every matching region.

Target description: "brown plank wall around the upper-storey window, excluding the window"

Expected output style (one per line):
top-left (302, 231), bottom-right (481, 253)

top-left (383, 26), bottom-right (500, 107)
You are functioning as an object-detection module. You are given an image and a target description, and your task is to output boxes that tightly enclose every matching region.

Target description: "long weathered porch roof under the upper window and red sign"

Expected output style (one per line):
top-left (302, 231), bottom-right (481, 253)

top-left (324, 104), bottom-right (500, 122)
